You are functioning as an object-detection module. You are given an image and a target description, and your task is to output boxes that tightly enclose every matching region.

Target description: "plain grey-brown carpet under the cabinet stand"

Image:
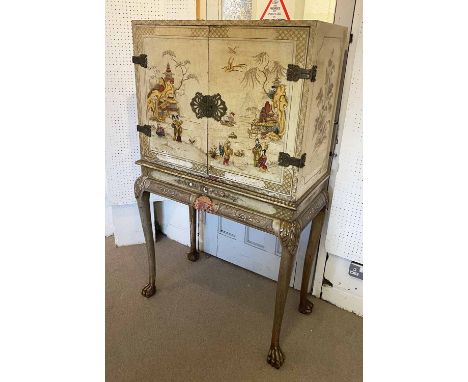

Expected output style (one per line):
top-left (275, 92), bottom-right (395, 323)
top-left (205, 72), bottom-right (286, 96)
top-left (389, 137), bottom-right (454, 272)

top-left (106, 237), bottom-right (362, 382)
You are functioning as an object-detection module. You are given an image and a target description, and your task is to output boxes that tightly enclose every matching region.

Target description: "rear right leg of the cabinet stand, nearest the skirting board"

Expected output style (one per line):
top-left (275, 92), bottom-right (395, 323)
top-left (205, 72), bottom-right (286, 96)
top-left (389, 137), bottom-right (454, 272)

top-left (299, 208), bottom-right (325, 314)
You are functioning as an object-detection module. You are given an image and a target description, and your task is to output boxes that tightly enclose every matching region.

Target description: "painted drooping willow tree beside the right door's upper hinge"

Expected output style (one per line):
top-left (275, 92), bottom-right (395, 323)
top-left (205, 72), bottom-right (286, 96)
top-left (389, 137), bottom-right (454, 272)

top-left (241, 52), bottom-right (286, 96)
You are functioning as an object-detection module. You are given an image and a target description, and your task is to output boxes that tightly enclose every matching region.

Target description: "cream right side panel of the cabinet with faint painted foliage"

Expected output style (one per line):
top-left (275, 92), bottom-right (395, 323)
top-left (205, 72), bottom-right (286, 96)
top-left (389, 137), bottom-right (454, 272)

top-left (296, 23), bottom-right (347, 198)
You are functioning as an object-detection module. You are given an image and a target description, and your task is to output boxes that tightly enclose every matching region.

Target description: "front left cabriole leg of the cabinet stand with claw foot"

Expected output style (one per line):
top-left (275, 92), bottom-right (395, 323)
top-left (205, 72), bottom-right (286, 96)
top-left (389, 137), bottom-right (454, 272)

top-left (136, 191), bottom-right (156, 297)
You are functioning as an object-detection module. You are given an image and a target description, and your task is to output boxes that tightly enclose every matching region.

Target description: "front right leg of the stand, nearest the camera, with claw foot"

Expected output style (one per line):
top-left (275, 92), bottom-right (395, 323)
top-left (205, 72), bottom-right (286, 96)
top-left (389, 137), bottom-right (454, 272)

top-left (267, 223), bottom-right (300, 369)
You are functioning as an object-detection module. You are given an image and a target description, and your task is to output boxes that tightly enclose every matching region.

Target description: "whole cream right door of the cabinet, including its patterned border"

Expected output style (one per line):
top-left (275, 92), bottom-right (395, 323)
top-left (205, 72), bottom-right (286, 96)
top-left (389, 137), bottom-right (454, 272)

top-left (207, 25), bottom-right (310, 196)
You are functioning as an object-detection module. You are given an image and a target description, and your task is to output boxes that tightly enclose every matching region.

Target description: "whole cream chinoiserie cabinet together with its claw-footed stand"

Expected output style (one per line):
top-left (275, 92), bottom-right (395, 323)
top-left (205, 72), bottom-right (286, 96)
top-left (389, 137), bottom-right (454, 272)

top-left (132, 21), bottom-right (348, 368)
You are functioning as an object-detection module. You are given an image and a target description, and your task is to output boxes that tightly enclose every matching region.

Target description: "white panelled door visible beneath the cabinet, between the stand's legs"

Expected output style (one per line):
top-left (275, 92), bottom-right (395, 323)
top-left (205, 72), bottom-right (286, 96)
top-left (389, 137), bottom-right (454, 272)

top-left (199, 212), bottom-right (310, 289)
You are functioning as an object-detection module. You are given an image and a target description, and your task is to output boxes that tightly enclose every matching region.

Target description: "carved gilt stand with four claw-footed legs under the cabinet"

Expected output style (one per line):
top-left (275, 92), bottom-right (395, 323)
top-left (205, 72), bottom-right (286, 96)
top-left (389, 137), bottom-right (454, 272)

top-left (135, 176), bottom-right (326, 369)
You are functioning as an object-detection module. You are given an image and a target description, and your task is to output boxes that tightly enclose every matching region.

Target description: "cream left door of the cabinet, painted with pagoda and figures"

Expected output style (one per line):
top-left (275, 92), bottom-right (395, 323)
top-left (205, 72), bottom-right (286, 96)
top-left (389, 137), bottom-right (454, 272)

top-left (133, 21), bottom-right (208, 175)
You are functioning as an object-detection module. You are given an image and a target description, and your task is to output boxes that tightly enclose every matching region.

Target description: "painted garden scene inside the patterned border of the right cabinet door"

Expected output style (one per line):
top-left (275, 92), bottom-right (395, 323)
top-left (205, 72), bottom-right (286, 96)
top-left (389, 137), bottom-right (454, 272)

top-left (208, 42), bottom-right (291, 181)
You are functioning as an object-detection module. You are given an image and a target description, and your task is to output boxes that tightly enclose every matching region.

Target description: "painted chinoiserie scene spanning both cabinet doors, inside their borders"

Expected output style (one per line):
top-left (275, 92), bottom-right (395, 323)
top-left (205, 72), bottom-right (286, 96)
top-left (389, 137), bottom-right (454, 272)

top-left (145, 39), bottom-right (294, 182)
